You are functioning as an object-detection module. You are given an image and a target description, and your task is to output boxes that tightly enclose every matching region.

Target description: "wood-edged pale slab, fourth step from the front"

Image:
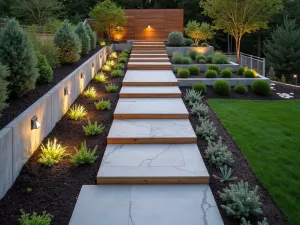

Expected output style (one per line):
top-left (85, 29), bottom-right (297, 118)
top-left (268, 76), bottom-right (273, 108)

top-left (114, 98), bottom-right (189, 119)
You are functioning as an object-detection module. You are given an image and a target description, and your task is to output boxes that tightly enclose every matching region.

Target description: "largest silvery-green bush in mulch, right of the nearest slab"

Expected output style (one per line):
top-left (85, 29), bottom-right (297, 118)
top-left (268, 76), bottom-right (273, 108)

top-left (219, 181), bottom-right (263, 218)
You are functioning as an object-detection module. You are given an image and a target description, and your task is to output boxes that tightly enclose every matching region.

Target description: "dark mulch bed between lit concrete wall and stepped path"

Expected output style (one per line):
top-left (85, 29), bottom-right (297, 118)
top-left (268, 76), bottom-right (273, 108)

top-left (0, 66), bottom-right (122, 225)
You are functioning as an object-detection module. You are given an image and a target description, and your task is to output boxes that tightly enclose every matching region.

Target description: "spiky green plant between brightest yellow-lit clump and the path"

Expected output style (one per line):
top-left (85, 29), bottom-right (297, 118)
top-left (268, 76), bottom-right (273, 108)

top-left (71, 141), bottom-right (97, 166)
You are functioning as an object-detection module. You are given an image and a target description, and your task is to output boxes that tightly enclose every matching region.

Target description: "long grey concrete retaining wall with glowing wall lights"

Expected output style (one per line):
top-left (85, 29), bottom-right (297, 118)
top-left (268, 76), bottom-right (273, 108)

top-left (0, 47), bottom-right (111, 199)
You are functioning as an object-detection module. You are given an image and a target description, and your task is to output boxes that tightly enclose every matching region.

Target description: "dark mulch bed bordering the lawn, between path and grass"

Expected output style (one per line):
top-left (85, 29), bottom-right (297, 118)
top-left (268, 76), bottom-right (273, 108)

top-left (181, 85), bottom-right (292, 225)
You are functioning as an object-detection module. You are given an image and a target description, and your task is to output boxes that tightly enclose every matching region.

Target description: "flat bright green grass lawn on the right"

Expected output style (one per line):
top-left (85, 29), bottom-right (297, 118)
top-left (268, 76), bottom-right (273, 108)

top-left (208, 99), bottom-right (300, 225)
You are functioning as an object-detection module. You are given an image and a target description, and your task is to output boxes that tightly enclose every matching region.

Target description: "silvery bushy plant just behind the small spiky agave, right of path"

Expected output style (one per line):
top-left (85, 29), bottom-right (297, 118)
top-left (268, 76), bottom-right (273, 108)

top-left (205, 137), bottom-right (234, 168)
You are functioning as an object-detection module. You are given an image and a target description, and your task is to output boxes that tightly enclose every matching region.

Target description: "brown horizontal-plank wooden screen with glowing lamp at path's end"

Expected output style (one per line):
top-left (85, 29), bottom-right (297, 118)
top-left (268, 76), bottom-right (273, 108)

top-left (114, 9), bottom-right (183, 40)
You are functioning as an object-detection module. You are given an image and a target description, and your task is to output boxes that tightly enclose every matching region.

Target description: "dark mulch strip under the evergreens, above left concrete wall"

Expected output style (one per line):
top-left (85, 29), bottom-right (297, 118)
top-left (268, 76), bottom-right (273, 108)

top-left (0, 46), bottom-right (103, 129)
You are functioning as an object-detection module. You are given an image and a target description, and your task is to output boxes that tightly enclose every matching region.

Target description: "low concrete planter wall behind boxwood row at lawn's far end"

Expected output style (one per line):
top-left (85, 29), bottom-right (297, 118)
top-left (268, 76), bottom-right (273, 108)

top-left (177, 75), bottom-right (270, 87)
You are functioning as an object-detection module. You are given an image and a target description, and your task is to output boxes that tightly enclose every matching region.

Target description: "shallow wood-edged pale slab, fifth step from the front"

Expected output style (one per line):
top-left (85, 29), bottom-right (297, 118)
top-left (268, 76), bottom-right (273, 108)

top-left (120, 86), bottom-right (181, 98)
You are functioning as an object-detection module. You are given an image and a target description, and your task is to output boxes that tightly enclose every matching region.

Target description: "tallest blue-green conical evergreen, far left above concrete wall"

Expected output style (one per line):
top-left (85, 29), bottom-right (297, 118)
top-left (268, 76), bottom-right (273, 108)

top-left (0, 19), bottom-right (38, 97)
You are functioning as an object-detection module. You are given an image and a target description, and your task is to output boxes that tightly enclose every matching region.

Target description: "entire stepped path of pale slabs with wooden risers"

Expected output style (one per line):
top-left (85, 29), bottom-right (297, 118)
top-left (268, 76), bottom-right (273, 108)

top-left (70, 41), bottom-right (223, 225)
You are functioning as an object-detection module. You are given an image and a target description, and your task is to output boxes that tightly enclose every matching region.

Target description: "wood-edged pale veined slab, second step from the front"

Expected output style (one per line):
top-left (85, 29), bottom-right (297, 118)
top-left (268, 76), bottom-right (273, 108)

top-left (97, 144), bottom-right (209, 184)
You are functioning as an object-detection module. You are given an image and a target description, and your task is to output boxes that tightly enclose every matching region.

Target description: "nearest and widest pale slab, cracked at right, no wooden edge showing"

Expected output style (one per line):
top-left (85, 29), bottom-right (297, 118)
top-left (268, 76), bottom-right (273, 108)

top-left (69, 184), bottom-right (224, 225)
